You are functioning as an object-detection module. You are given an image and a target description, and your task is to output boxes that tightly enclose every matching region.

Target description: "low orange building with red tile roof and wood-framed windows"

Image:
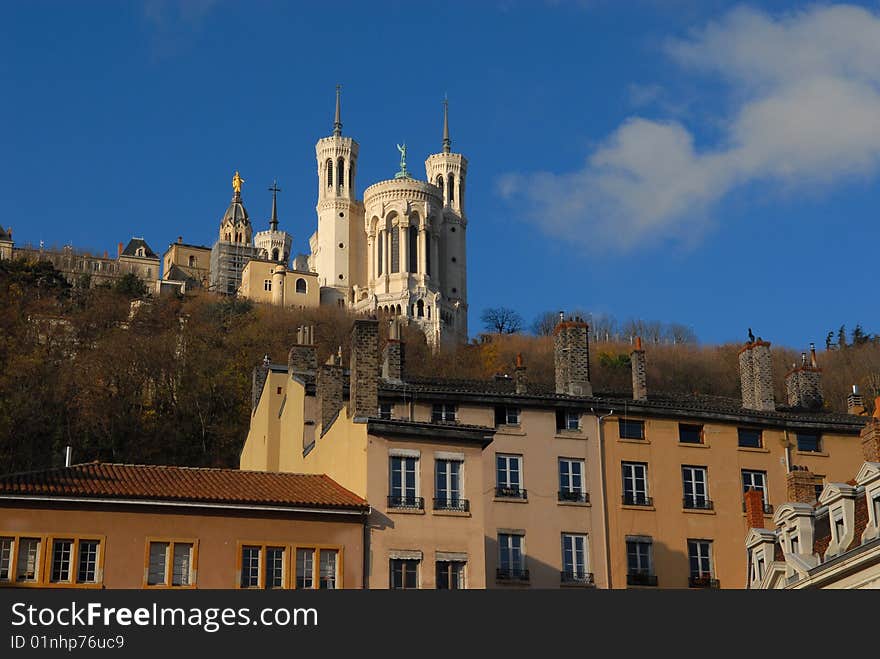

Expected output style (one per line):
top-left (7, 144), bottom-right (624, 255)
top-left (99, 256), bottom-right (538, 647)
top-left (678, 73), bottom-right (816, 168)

top-left (0, 463), bottom-right (369, 589)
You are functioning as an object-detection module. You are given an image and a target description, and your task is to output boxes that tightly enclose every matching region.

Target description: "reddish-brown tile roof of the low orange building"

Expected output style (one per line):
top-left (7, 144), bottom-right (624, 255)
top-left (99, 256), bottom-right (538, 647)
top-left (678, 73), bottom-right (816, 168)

top-left (0, 462), bottom-right (368, 511)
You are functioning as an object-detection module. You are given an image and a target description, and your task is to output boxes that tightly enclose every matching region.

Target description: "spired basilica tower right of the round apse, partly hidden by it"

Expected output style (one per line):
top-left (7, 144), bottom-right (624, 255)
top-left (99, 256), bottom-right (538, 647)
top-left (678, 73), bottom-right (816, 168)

top-left (425, 100), bottom-right (468, 340)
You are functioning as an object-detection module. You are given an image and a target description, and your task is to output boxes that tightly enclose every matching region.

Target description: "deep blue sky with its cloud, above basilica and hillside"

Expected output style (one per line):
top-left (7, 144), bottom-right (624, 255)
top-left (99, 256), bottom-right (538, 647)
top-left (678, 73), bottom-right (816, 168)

top-left (0, 0), bottom-right (880, 348)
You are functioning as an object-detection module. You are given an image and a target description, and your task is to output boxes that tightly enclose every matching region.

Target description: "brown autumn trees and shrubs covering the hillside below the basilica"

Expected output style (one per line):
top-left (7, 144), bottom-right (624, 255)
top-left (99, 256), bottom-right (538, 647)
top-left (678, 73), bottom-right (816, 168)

top-left (0, 261), bottom-right (880, 472)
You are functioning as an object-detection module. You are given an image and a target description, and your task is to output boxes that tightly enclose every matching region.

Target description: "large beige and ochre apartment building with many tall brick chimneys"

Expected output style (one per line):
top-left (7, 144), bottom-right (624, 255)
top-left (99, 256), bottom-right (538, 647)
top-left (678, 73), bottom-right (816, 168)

top-left (241, 319), bottom-right (865, 588)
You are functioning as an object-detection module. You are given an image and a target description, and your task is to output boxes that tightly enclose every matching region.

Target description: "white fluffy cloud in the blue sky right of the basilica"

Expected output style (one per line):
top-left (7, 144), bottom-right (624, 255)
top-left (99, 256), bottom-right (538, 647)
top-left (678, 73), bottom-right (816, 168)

top-left (499, 6), bottom-right (880, 250)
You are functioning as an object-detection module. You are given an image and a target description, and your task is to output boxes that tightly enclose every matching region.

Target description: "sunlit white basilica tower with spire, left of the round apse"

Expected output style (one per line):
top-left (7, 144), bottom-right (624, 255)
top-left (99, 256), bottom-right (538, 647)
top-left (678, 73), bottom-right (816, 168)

top-left (309, 86), bottom-right (366, 306)
